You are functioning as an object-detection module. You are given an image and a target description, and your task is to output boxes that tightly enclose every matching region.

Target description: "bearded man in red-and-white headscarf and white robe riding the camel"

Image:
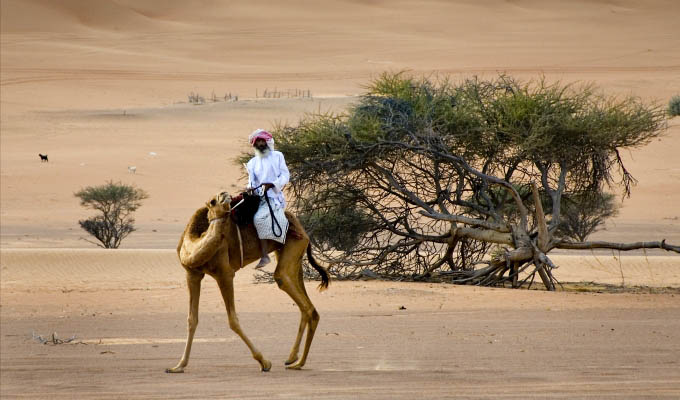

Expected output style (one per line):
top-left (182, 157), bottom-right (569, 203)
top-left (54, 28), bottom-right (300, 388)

top-left (246, 129), bottom-right (290, 269)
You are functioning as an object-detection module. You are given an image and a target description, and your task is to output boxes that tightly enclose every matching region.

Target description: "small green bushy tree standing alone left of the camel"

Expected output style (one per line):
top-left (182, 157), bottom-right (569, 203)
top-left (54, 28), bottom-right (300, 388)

top-left (74, 181), bottom-right (149, 249)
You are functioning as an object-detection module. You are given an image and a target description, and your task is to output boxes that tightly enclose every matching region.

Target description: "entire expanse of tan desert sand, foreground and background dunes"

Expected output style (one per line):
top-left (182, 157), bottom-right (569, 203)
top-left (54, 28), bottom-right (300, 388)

top-left (0, 0), bottom-right (680, 399)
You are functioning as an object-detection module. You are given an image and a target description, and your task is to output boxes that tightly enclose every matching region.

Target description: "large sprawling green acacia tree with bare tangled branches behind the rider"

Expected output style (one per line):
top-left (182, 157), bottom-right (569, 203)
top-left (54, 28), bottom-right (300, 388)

top-left (266, 74), bottom-right (680, 290)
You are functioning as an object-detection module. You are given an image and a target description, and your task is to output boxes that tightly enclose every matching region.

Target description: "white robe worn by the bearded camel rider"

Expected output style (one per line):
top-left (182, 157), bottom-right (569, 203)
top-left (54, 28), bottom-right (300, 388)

top-left (246, 151), bottom-right (290, 243)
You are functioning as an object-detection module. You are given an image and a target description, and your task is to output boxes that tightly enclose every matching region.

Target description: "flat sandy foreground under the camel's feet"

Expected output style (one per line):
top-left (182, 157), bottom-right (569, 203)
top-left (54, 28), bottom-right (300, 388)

top-left (0, 249), bottom-right (680, 399)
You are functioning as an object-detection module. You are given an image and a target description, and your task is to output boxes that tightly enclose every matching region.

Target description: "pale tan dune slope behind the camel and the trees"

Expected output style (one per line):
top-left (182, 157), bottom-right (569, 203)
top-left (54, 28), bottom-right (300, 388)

top-left (0, 0), bottom-right (680, 248)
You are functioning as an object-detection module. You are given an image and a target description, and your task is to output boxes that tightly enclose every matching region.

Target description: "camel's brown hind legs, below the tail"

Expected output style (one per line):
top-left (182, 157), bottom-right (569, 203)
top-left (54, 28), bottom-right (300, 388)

top-left (274, 247), bottom-right (320, 369)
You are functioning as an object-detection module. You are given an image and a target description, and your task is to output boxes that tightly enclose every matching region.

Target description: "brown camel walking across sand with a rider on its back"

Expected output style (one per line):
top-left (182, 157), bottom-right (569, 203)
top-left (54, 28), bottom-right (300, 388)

top-left (165, 192), bottom-right (329, 373)
